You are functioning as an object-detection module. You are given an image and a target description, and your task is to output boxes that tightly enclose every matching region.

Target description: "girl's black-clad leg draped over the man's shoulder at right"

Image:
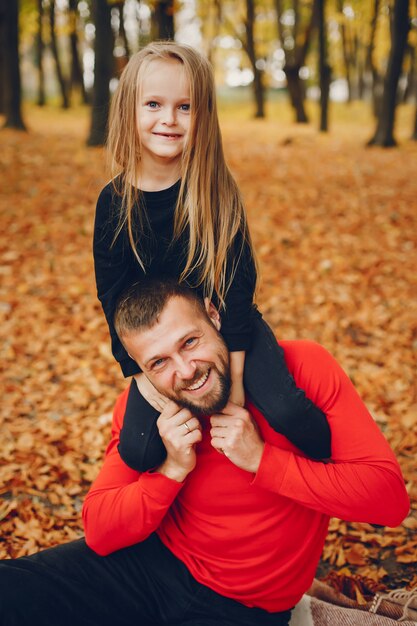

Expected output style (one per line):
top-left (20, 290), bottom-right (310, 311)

top-left (244, 311), bottom-right (331, 459)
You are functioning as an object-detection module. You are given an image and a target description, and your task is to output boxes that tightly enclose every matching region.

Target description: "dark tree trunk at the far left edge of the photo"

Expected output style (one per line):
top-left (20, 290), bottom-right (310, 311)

top-left (0, 0), bottom-right (26, 130)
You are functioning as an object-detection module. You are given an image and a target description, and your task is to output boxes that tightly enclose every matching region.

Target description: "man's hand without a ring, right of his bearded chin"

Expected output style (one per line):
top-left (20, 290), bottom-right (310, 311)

top-left (210, 402), bottom-right (265, 473)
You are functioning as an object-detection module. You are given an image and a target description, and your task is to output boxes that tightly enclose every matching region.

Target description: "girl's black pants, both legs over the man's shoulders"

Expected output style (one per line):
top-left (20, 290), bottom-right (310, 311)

top-left (119, 309), bottom-right (331, 472)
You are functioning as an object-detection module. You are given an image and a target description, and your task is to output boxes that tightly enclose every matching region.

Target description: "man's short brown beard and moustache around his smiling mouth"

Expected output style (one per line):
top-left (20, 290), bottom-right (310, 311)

top-left (170, 357), bottom-right (231, 417)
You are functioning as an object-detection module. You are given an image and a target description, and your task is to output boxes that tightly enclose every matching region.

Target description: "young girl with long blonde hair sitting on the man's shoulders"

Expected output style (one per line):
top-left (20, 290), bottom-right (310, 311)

top-left (94, 42), bottom-right (330, 471)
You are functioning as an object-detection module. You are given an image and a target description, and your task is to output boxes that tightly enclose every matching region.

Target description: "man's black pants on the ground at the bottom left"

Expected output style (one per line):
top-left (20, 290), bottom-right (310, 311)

top-left (0, 534), bottom-right (291, 626)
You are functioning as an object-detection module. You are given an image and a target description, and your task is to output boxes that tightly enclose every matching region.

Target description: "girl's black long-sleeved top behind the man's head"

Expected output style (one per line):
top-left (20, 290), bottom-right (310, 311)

top-left (93, 181), bottom-right (256, 377)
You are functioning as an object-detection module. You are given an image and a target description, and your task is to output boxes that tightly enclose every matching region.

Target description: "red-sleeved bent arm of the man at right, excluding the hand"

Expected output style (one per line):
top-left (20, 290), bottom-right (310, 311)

top-left (249, 341), bottom-right (409, 526)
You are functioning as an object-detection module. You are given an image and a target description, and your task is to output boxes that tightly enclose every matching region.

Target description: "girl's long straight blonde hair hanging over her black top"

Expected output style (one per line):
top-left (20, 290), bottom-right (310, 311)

top-left (107, 42), bottom-right (255, 306)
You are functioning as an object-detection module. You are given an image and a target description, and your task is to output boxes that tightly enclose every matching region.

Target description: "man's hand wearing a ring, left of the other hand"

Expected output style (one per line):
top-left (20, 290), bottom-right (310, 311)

top-left (157, 400), bottom-right (202, 482)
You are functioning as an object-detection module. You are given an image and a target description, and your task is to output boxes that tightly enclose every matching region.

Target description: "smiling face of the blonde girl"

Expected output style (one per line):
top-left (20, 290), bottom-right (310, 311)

top-left (136, 59), bottom-right (191, 165)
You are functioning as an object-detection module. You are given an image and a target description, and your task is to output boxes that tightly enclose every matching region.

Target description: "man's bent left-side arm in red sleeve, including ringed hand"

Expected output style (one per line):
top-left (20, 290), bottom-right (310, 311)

top-left (83, 390), bottom-right (201, 556)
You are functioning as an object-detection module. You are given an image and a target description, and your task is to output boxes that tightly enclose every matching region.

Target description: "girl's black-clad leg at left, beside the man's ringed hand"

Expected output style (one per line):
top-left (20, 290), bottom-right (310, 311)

top-left (119, 379), bottom-right (166, 472)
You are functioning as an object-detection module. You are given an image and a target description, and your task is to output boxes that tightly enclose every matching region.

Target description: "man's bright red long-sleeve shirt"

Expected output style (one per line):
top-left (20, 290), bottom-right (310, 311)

top-left (83, 341), bottom-right (409, 611)
